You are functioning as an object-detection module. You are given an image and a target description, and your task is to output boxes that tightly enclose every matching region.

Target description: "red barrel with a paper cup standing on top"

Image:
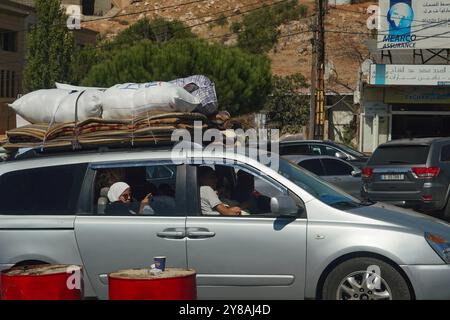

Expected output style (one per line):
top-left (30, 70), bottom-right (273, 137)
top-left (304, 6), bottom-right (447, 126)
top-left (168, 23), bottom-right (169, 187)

top-left (108, 268), bottom-right (197, 300)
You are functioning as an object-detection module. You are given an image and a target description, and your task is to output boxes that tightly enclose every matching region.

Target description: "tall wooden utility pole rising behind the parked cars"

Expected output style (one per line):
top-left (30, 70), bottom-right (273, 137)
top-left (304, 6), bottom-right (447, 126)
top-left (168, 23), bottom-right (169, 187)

top-left (310, 0), bottom-right (327, 140)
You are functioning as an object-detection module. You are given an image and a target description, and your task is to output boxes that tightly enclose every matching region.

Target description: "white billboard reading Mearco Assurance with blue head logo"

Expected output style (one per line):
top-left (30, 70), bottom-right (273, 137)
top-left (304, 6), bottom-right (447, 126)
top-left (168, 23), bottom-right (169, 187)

top-left (378, 0), bottom-right (450, 50)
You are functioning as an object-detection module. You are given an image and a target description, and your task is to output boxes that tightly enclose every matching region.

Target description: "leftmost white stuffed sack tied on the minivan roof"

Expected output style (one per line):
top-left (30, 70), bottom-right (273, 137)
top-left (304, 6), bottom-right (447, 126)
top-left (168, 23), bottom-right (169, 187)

top-left (9, 89), bottom-right (103, 123)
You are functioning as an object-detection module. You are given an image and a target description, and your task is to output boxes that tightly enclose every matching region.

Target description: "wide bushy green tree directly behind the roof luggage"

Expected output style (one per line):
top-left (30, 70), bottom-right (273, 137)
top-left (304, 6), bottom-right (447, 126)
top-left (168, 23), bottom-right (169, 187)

top-left (82, 39), bottom-right (271, 115)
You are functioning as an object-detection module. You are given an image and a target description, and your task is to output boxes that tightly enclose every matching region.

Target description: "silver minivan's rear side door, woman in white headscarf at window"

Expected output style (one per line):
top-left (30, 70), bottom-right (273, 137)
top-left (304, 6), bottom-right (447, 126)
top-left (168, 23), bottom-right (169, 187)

top-left (75, 161), bottom-right (187, 299)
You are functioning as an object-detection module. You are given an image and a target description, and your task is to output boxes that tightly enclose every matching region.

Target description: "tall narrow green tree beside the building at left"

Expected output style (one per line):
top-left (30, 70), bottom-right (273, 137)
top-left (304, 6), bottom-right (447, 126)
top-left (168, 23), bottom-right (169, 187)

top-left (23, 0), bottom-right (75, 92)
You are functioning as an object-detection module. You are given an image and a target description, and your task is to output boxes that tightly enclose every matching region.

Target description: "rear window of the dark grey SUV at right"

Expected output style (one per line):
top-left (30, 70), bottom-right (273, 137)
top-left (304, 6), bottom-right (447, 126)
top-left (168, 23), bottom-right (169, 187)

top-left (368, 145), bottom-right (430, 165)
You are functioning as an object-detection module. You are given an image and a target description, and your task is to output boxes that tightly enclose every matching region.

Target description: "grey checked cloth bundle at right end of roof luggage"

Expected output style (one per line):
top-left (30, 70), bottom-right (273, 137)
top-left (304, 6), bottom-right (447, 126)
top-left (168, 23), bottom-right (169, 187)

top-left (170, 75), bottom-right (219, 116)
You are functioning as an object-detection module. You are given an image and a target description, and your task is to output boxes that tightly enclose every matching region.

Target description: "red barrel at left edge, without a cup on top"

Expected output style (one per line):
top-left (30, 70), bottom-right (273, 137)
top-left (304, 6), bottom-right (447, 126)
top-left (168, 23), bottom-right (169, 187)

top-left (0, 264), bottom-right (82, 300)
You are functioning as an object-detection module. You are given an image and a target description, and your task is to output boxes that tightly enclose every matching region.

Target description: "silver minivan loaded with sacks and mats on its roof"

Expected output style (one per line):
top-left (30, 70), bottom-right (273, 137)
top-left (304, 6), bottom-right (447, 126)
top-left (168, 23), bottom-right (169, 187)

top-left (0, 149), bottom-right (450, 300)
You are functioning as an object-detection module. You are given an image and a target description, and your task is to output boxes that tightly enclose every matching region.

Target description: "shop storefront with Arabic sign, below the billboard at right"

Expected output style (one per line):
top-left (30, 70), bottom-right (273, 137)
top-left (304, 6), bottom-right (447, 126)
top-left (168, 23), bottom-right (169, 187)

top-left (360, 65), bottom-right (450, 152)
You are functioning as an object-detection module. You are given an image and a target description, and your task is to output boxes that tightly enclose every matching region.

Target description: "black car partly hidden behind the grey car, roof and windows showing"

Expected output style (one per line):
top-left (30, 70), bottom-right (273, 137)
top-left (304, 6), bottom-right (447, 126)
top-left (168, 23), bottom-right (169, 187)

top-left (280, 140), bottom-right (369, 168)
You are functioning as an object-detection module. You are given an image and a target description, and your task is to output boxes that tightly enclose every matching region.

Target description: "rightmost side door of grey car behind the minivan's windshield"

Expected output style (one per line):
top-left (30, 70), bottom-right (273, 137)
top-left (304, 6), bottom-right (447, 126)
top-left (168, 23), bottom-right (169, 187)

top-left (321, 159), bottom-right (362, 198)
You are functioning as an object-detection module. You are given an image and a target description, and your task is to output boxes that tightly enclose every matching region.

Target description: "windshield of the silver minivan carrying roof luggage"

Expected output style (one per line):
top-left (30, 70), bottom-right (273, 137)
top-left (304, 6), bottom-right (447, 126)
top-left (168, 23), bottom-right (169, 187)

top-left (266, 158), bottom-right (371, 209)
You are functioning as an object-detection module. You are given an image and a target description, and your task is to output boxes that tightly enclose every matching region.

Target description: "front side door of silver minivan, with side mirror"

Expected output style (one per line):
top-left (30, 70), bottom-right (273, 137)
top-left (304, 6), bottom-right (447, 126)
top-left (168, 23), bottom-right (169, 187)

top-left (186, 164), bottom-right (307, 299)
